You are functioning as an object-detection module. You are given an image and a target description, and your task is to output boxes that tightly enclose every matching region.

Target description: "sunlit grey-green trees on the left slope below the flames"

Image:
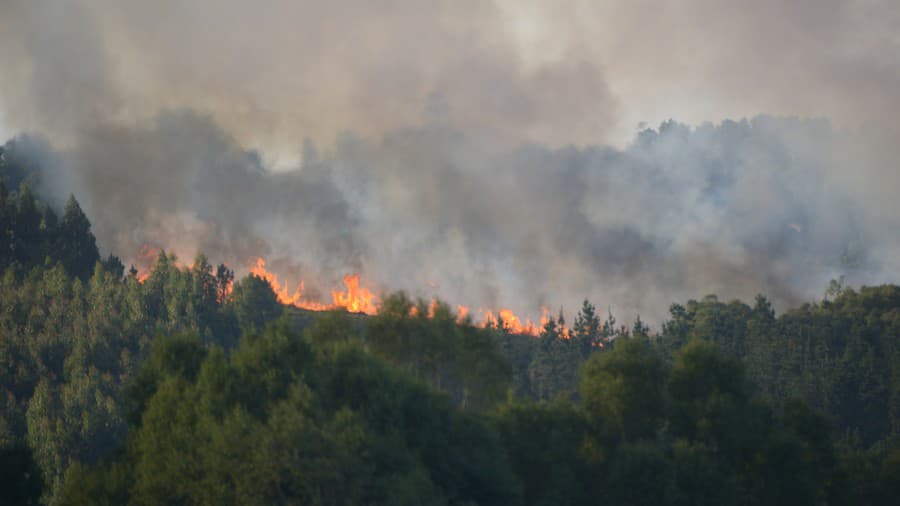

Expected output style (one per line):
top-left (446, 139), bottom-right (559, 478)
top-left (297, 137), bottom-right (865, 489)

top-left (0, 253), bottom-right (281, 502)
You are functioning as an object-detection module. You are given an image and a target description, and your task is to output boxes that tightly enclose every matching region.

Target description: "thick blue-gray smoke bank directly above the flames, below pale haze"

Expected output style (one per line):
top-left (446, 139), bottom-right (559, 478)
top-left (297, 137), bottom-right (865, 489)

top-left (14, 111), bottom-right (900, 318)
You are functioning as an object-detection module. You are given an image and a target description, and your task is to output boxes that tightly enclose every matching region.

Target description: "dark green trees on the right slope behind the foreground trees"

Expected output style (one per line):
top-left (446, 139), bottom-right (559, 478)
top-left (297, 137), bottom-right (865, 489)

top-left (661, 284), bottom-right (900, 445)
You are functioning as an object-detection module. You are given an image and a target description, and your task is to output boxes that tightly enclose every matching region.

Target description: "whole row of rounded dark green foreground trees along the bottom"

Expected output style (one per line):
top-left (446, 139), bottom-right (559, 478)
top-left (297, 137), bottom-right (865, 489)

top-left (60, 323), bottom-right (897, 505)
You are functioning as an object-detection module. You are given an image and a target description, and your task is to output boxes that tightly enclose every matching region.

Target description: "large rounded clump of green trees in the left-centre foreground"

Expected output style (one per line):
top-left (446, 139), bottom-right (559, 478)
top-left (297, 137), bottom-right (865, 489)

top-left (63, 326), bottom-right (518, 505)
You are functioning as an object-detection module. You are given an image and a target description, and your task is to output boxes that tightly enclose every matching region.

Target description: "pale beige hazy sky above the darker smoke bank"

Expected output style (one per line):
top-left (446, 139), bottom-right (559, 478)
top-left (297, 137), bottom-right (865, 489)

top-left (0, 0), bottom-right (900, 152)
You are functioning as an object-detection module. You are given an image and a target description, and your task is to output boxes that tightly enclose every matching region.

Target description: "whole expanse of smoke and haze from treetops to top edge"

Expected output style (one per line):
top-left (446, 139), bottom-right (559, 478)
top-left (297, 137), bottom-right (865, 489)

top-left (0, 0), bottom-right (900, 321)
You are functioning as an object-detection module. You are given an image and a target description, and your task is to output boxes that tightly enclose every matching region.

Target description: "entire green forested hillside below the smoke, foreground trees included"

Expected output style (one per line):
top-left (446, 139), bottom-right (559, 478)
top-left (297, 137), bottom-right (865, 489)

top-left (0, 142), bottom-right (900, 505)
